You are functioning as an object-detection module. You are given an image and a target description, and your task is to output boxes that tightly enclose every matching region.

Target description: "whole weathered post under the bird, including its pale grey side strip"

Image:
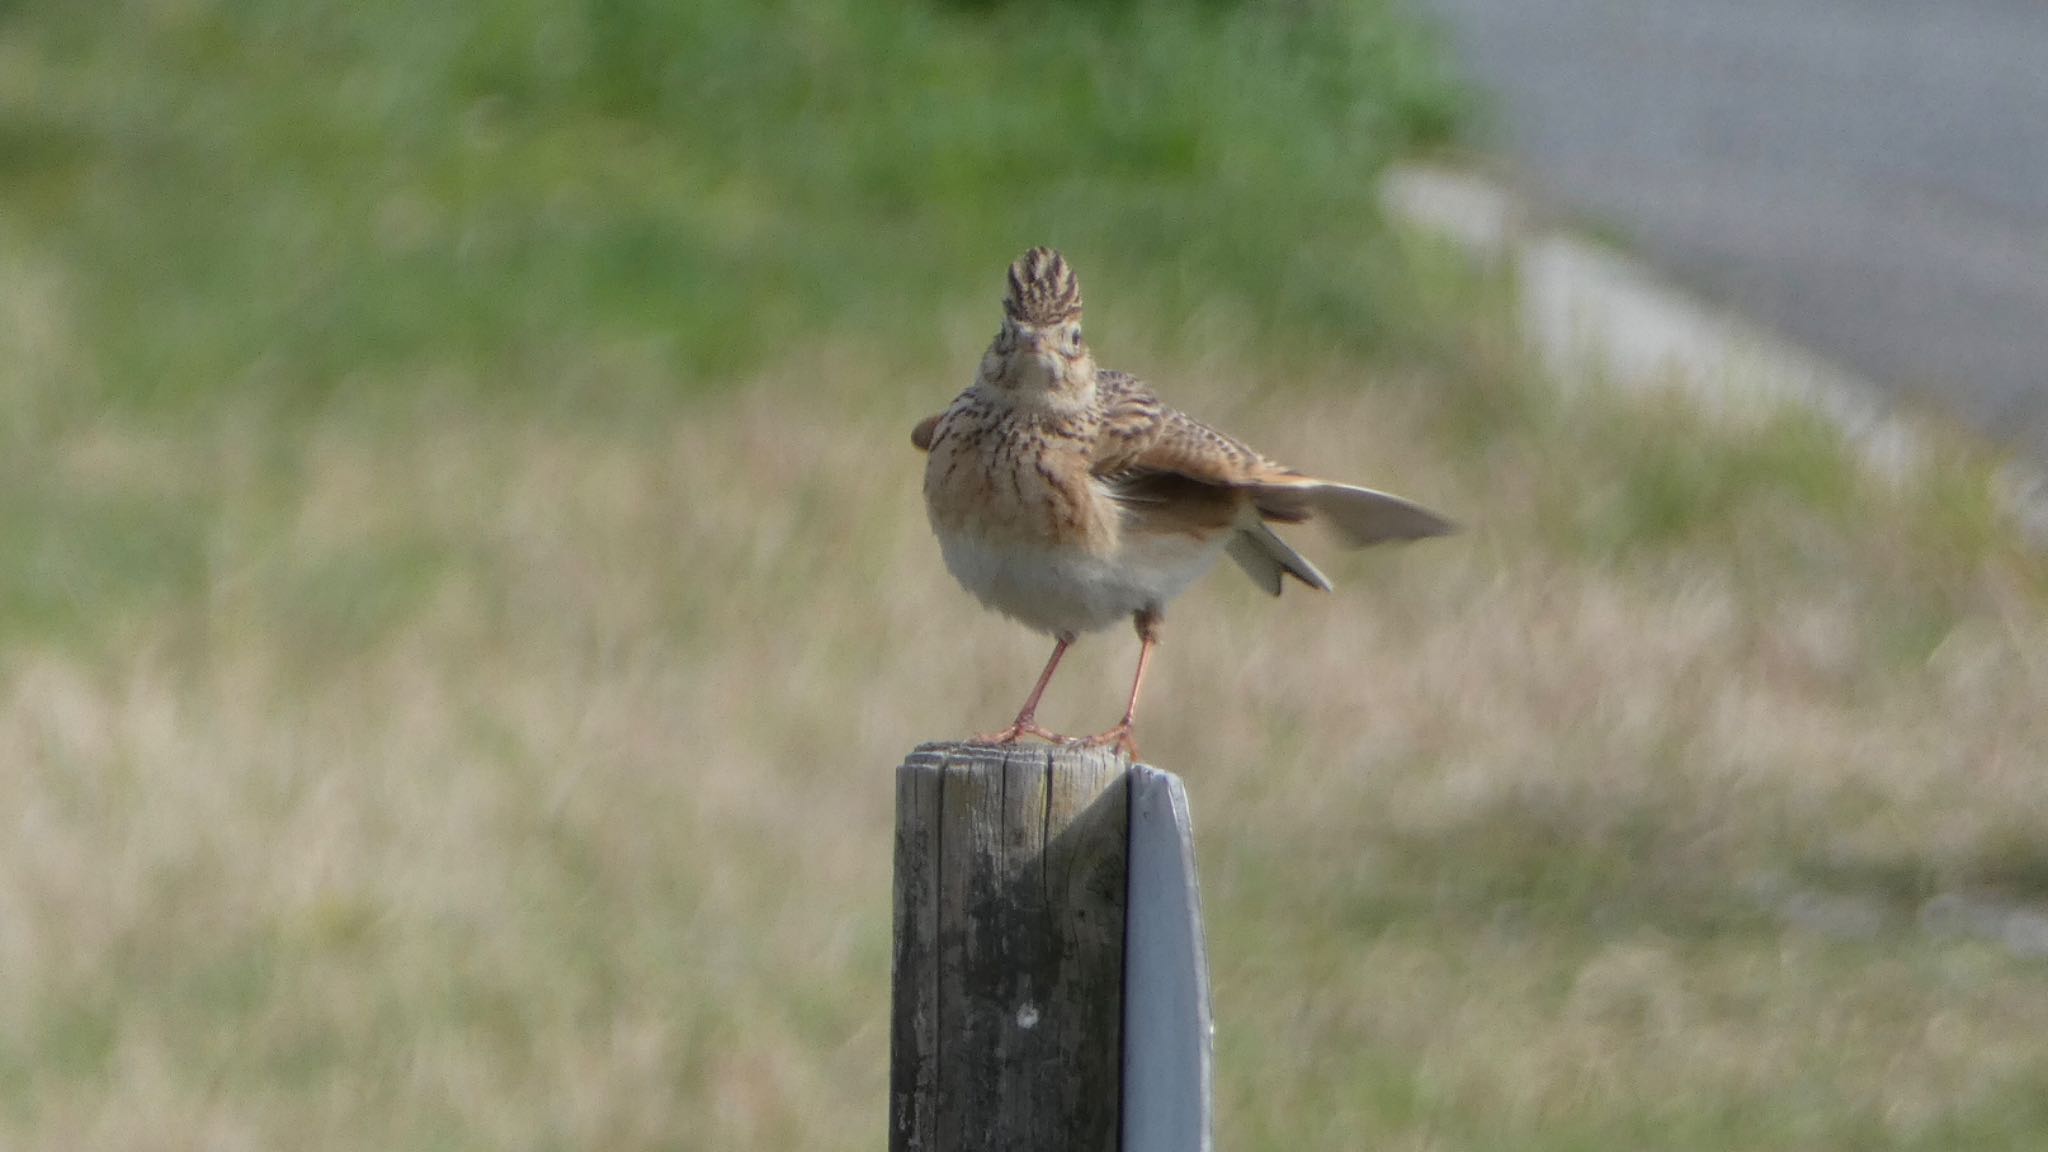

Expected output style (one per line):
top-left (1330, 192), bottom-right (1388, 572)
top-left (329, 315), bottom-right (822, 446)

top-left (889, 742), bottom-right (1210, 1152)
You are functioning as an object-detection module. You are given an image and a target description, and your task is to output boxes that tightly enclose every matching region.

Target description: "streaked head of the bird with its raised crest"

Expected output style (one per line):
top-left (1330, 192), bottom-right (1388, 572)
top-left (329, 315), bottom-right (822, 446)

top-left (981, 248), bottom-right (1096, 406)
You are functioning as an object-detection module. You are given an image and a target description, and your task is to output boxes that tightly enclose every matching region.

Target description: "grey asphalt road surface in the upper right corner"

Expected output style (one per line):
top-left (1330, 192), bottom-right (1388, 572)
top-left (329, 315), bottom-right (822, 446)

top-left (1419, 0), bottom-right (2048, 459)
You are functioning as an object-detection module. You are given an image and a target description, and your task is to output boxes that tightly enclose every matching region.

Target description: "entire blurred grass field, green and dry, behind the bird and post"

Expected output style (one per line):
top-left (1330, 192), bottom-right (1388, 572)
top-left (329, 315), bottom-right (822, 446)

top-left (0, 0), bottom-right (2048, 1152)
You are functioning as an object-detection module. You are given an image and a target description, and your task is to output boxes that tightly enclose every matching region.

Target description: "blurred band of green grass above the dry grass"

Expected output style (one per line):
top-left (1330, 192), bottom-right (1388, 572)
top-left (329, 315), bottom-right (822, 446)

top-left (0, 0), bottom-right (1458, 406)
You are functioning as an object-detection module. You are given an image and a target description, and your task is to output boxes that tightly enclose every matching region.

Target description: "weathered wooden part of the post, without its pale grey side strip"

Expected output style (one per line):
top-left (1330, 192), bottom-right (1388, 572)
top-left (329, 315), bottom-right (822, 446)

top-left (889, 744), bottom-right (1128, 1152)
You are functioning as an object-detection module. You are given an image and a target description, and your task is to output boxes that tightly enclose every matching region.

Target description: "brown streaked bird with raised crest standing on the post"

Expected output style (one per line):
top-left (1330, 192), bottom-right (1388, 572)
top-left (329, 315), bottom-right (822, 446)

top-left (911, 248), bottom-right (1454, 754)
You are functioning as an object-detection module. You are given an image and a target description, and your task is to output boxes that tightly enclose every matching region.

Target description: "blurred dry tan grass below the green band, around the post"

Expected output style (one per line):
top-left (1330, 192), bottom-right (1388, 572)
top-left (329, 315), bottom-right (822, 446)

top-left (0, 325), bottom-right (2048, 1152)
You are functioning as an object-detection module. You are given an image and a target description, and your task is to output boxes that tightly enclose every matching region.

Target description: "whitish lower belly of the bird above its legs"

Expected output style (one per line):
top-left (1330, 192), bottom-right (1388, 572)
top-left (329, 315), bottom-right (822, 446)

top-left (938, 533), bottom-right (1229, 635)
